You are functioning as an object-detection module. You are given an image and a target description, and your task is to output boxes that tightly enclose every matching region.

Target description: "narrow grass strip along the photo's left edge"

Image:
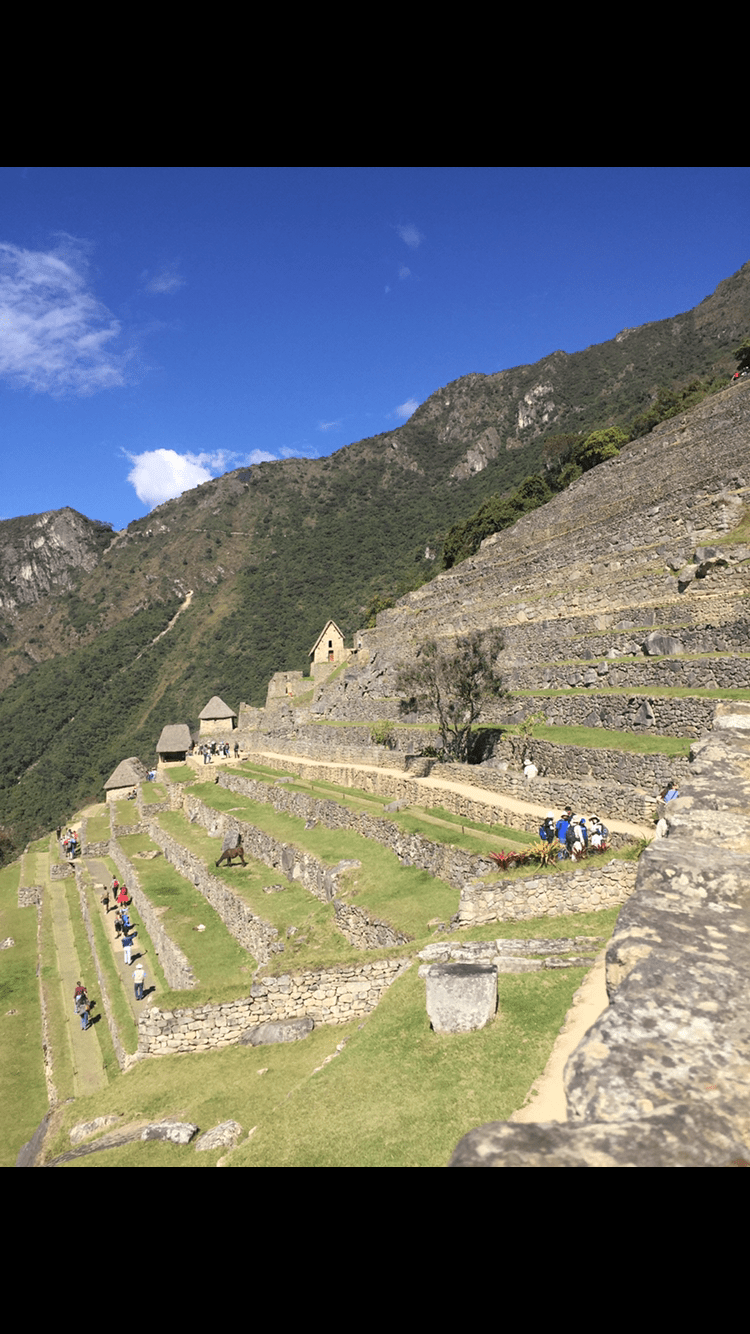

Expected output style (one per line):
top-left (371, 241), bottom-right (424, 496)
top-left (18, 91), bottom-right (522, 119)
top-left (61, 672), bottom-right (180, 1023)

top-left (0, 862), bottom-right (48, 1167)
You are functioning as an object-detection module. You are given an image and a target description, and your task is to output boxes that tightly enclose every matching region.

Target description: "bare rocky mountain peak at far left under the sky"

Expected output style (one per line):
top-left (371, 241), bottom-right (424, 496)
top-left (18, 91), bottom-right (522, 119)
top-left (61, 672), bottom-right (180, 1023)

top-left (0, 508), bottom-right (113, 614)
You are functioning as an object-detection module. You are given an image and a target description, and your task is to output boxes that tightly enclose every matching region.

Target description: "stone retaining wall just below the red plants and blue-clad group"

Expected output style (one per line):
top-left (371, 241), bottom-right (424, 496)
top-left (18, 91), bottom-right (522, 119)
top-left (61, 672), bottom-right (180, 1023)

top-left (452, 858), bottom-right (638, 926)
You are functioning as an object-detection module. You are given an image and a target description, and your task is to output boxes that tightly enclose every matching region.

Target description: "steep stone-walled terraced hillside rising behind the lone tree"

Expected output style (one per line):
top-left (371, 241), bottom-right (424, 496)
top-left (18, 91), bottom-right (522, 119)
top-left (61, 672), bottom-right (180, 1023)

top-left (312, 382), bottom-right (750, 735)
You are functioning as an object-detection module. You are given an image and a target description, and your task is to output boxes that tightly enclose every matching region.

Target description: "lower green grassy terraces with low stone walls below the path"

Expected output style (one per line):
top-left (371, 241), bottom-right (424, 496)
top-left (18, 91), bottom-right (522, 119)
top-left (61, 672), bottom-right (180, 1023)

top-left (0, 762), bottom-right (635, 1166)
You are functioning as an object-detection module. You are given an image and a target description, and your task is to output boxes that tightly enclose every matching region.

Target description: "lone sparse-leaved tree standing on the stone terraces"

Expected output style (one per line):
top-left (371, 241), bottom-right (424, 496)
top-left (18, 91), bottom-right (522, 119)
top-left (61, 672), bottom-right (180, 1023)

top-left (396, 631), bottom-right (508, 763)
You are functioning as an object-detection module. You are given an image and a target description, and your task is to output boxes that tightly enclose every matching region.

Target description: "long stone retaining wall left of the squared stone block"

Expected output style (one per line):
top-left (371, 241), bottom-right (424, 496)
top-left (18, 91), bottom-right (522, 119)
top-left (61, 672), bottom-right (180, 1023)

top-left (139, 959), bottom-right (411, 1057)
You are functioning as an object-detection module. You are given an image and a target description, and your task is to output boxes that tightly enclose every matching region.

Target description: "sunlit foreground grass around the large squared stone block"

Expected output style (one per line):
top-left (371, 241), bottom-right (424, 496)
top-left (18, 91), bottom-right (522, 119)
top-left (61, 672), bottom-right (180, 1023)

top-left (38, 910), bottom-right (617, 1167)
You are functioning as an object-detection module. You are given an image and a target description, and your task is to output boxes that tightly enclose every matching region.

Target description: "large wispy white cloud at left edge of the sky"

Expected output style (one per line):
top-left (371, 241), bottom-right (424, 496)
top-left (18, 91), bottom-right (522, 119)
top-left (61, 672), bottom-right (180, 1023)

top-left (0, 236), bottom-right (128, 396)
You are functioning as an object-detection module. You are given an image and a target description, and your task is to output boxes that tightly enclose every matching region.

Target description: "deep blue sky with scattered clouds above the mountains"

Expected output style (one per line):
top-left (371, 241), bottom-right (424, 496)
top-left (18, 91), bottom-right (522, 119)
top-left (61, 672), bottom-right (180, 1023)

top-left (0, 167), bottom-right (750, 528)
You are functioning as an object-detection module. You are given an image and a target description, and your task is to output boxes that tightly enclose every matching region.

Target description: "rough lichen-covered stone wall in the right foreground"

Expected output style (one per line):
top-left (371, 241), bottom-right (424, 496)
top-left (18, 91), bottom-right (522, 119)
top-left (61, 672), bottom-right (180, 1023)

top-left (452, 703), bottom-right (750, 1167)
